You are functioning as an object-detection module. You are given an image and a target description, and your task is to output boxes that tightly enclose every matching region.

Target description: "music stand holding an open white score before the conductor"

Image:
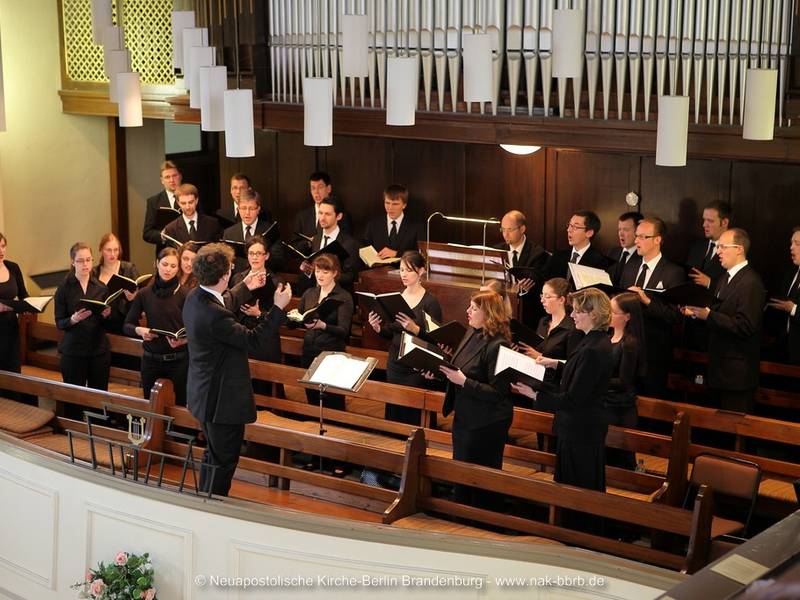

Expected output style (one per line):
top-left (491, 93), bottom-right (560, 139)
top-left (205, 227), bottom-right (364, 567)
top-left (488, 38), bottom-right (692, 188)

top-left (297, 351), bottom-right (378, 435)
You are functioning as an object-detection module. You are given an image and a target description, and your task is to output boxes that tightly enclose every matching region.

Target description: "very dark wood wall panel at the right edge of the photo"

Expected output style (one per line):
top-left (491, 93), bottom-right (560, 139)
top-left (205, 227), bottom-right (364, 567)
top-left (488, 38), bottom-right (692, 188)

top-left (731, 161), bottom-right (800, 295)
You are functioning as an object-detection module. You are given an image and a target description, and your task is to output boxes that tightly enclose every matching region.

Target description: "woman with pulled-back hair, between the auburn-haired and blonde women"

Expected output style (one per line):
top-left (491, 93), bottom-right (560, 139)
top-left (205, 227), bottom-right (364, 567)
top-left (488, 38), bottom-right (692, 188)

top-left (520, 277), bottom-right (583, 390)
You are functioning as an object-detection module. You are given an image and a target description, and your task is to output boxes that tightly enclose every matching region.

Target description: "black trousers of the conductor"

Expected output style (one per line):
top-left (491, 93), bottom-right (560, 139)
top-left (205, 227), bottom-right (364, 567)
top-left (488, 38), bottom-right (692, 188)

top-left (200, 421), bottom-right (244, 496)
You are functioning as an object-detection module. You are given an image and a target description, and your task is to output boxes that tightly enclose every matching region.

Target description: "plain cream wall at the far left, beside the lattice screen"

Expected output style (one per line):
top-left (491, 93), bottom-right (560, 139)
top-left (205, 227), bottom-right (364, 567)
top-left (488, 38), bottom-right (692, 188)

top-left (0, 0), bottom-right (111, 293)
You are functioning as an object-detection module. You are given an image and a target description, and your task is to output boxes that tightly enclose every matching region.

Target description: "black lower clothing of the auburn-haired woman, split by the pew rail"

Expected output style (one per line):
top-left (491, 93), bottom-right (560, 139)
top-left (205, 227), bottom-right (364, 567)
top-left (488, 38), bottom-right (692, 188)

top-left (453, 413), bottom-right (511, 509)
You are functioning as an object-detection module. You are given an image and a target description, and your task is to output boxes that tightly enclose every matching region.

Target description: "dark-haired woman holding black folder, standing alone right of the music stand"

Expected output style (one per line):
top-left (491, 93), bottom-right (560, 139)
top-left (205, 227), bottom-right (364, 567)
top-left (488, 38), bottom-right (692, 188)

top-left (369, 250), bottom-right (442, 425)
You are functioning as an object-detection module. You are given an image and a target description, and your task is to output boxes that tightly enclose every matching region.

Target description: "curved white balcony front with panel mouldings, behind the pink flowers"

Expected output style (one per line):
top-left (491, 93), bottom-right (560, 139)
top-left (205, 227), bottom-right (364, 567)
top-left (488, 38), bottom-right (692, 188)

top-left (0, 439), bottom-right (683, 600)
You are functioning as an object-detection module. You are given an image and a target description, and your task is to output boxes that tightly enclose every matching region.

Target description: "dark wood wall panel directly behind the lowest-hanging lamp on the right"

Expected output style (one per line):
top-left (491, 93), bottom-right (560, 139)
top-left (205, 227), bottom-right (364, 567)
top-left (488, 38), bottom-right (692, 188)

top-left (640, 156), bottom-right (730, 264)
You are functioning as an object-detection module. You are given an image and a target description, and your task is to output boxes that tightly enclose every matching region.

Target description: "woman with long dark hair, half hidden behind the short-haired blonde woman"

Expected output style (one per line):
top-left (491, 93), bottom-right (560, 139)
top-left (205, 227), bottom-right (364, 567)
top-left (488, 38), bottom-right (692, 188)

top-left (606, 292), bottom-right (647, 470)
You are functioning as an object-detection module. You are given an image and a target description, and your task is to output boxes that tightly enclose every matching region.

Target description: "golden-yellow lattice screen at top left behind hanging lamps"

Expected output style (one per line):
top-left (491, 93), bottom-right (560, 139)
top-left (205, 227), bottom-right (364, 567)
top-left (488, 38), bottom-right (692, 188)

top-left (61, 0), bottom-right (175, 85)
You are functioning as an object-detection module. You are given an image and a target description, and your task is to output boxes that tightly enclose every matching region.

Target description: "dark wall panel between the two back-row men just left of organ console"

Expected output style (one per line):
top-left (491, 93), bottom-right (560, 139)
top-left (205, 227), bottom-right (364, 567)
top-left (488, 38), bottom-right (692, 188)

top-left (319, 136), bottom-right (388, 238)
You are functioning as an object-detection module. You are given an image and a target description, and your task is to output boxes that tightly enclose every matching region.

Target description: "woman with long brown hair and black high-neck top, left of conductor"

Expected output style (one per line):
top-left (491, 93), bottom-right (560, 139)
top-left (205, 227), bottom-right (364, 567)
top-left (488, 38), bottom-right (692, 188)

top-left (124, 248), bottom-right (189, 406)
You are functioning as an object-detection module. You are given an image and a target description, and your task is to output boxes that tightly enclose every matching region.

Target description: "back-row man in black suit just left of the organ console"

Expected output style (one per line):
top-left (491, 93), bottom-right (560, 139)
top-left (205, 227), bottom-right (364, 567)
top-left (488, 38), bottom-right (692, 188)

top-left (364, 183), bottom-right (422, 258)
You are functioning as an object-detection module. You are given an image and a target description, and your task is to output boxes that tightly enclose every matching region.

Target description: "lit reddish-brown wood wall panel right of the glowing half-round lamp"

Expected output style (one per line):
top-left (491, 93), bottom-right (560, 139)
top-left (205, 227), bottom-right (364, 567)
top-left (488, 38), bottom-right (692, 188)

top-left (551, 150), bottom-right (638, 253)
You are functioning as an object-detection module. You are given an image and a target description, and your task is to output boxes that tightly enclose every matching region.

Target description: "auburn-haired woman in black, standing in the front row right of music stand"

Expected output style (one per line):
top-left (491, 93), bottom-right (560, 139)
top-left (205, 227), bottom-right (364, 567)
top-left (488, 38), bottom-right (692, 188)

top-left (439, 291), bottom-right (514, 506)
